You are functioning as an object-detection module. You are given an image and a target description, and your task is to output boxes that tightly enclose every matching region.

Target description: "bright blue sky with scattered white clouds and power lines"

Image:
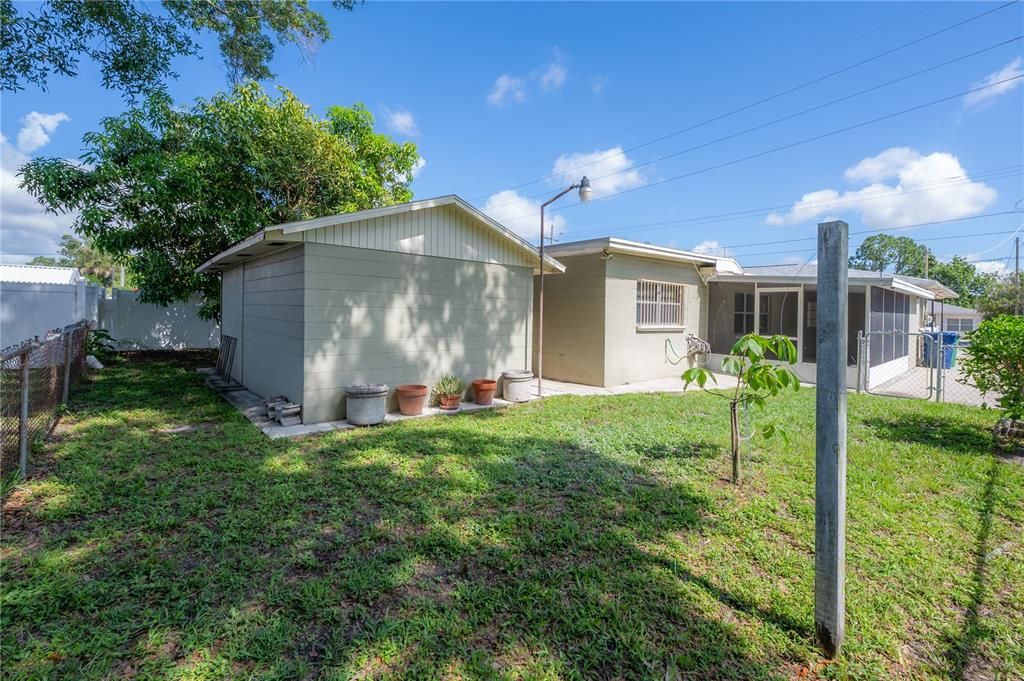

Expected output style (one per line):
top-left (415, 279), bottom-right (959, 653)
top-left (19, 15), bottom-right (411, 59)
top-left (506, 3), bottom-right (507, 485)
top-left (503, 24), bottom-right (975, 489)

top-left (0, 2), bottom-right (1024, 269)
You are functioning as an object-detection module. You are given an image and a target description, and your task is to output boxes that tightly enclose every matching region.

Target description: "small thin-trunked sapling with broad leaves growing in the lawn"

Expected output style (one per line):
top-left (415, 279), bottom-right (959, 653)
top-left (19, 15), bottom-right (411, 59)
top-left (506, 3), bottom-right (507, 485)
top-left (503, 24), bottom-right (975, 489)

top-left (682, 334), bottom-right (800, 484)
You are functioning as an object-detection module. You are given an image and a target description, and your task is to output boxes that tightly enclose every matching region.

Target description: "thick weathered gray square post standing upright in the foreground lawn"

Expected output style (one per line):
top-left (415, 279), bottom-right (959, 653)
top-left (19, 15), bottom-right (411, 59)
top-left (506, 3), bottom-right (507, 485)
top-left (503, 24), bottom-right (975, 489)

top-left (814, 221), bottom-right (849, 658)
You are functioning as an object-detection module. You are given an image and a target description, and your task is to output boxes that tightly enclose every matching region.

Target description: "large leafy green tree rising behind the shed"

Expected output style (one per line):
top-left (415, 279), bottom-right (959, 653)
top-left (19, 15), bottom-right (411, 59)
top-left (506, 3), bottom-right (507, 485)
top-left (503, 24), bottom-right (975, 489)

top-left (23, 83), bottom-right (419, 316)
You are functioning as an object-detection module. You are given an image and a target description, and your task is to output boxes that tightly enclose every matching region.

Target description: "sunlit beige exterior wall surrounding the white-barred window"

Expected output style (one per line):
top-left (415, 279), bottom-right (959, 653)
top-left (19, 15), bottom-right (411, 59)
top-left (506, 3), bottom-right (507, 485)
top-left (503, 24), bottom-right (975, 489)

top-left (604, 254), bottom-right (708, 385)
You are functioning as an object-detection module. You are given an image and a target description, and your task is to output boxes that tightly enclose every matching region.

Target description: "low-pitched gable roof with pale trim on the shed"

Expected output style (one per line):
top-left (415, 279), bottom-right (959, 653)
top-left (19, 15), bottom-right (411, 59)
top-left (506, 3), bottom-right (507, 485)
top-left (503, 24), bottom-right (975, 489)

top-left (196, 194), bottom-right (565, 272)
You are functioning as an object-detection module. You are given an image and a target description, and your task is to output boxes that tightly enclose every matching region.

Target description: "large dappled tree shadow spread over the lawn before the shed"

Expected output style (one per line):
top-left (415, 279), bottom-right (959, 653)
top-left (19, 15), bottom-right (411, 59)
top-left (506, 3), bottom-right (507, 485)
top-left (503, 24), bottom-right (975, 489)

top-left (2, 352), bottom-right (811, 679)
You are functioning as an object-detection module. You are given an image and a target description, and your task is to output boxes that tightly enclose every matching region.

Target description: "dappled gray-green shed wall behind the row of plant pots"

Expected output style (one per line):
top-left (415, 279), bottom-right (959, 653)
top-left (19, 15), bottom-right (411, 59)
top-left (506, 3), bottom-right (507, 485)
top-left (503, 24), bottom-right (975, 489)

top-left (299, 241), bottom-right (532, 422)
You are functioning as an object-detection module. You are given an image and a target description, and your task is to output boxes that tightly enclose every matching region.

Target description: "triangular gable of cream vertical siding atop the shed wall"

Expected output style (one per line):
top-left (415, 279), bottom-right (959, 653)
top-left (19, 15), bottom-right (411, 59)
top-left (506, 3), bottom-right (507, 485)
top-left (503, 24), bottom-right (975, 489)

top-left (302, 206), bottom-right (532, 267)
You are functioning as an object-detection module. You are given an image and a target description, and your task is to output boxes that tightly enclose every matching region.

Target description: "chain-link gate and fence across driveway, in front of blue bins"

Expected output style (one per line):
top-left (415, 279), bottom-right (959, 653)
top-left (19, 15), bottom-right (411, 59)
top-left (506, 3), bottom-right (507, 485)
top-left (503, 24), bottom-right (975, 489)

top-left (857, 331), bottom-right (995, 407)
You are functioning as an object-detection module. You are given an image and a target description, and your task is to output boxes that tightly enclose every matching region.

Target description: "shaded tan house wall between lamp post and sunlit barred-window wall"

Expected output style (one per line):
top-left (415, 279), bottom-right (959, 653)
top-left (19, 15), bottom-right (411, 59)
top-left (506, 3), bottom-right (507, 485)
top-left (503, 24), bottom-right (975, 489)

top-left (532, 254), bottom-right (605, 385)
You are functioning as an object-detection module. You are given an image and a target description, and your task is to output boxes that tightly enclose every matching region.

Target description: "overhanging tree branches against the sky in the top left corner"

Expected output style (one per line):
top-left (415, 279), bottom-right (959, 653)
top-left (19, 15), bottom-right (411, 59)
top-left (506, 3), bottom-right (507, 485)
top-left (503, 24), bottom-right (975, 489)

top-left (0, 0), bottom-right (355, 97)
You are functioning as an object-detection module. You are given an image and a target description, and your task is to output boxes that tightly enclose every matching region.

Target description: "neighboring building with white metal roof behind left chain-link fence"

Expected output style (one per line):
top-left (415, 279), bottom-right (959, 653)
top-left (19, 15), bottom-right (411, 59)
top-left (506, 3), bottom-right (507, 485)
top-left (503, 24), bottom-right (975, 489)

top-left (0, 264), bottom-right (98, 347)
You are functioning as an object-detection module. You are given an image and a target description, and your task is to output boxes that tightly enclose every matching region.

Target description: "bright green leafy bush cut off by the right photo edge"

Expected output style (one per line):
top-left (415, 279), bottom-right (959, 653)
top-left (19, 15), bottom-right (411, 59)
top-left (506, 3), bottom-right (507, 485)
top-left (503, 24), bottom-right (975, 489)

top-left (964, 314), bottom-right (1024, 420)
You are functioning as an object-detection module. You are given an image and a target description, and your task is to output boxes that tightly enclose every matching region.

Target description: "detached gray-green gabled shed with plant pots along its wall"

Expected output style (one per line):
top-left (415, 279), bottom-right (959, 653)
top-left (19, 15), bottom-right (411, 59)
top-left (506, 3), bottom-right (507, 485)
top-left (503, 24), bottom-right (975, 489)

top-left (197, 196), bottom-right (564, 423)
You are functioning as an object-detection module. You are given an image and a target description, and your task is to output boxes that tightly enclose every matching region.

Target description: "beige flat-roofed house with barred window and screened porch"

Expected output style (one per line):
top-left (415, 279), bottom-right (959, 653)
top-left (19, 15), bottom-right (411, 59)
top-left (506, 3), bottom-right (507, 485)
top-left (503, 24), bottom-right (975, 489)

top-left (535, 238), bottom-right (955, 386)
